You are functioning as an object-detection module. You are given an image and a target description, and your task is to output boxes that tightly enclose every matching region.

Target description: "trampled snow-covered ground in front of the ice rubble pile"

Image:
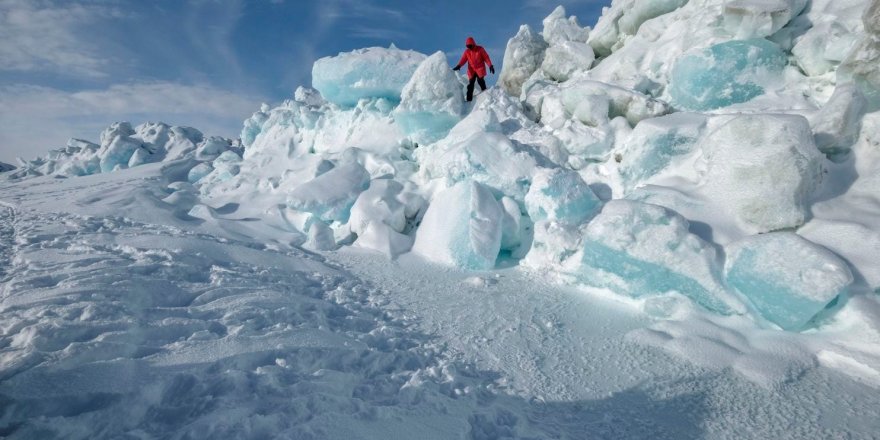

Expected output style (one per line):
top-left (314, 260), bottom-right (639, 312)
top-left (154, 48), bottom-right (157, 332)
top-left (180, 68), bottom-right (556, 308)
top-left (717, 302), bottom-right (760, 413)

top-left (0, 154), bottom-right (880, 439)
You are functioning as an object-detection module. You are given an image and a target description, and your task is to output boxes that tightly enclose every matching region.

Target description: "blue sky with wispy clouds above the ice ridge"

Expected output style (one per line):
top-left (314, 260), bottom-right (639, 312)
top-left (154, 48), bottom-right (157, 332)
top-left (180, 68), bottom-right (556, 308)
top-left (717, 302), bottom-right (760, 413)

top-left (0, 0), bottom-right (610, 163)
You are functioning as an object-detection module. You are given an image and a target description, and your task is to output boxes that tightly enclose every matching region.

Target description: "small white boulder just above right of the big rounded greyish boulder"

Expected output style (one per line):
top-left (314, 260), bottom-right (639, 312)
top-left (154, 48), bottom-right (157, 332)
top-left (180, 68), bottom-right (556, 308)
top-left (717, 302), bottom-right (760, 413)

top-left (810, 84), bottom-right (868, 154)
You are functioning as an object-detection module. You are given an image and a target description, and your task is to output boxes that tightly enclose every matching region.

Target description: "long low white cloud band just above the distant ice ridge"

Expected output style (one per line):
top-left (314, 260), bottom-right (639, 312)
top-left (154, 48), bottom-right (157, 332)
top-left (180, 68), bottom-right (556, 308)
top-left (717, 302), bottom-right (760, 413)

top-left (0, 82), bottom-right (262, 162)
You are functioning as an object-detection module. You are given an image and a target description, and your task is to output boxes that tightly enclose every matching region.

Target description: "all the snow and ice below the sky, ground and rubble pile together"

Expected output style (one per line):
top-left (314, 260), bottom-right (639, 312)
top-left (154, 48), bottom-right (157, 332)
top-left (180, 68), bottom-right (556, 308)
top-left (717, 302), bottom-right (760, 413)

top-left (0, 0), bottom-right (880, 439)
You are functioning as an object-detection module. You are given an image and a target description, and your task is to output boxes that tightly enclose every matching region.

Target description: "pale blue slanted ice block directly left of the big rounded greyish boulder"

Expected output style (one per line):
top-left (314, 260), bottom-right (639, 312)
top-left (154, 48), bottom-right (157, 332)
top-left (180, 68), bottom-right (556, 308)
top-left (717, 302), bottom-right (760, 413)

top-left (618, 112), bottom-right (707, 191)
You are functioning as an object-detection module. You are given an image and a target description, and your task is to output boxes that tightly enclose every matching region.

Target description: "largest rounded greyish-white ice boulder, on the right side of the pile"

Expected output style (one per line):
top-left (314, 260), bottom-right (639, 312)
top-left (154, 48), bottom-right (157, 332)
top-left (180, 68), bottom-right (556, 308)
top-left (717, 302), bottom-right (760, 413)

top-left (700, 114), bottom-right (822, 234)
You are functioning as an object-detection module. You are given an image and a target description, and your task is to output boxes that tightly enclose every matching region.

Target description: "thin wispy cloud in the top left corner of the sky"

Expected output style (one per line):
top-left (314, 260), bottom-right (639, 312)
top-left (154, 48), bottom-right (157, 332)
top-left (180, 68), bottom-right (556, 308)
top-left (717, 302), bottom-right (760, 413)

top-left (0, 0), bottom-right (122, 77)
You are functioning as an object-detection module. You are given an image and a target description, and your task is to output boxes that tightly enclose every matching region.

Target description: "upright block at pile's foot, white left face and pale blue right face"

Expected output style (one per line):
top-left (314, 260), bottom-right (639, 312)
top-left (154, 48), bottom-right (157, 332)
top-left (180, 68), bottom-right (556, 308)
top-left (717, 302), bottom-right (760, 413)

top-left (413, 180), bottom-right (504, 270)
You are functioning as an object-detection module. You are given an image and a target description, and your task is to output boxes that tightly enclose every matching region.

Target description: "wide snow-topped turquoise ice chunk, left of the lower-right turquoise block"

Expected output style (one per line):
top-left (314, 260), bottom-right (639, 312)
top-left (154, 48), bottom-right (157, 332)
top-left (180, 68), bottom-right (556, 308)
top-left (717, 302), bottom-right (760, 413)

top-left (578, 200), bottom-right (737, 313)
